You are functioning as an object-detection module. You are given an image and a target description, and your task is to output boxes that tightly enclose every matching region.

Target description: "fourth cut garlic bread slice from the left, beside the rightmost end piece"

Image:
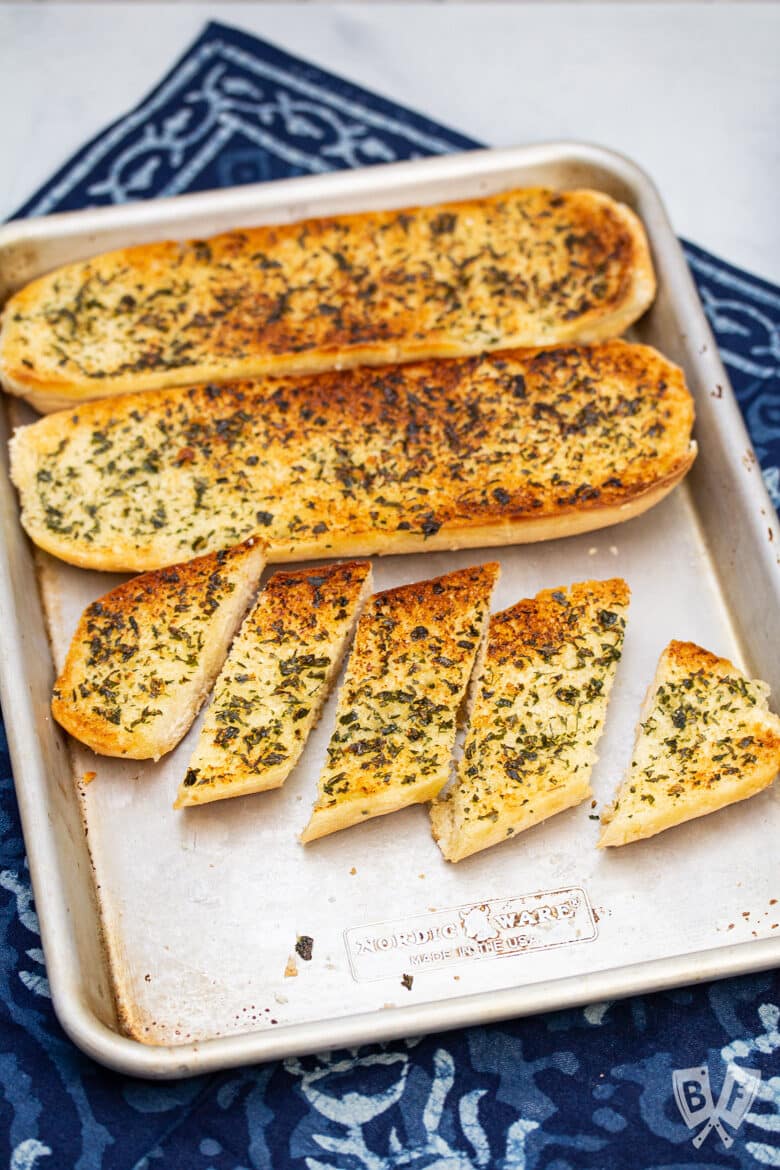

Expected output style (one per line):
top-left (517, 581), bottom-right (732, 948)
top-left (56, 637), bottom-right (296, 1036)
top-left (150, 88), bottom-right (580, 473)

top-left (430, 578), bottom-right (629, 861)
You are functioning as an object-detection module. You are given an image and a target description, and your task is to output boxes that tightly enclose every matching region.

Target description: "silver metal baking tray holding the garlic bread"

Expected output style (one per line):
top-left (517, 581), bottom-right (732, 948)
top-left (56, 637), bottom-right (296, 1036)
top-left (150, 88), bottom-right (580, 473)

top-left (0, 143), bottom-right (780, 1076)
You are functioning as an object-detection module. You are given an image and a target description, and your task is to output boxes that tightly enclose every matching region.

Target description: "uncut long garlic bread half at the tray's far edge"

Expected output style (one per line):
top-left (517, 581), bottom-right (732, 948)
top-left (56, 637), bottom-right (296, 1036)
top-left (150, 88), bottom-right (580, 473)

top-left (0, 188), bottom-right (655, 412)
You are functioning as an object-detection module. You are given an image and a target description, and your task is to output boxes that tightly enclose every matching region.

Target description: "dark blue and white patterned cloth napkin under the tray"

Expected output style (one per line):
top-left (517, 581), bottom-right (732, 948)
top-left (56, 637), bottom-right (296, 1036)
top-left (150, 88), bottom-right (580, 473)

top-left (0, 25), bottom-right (780, 1170)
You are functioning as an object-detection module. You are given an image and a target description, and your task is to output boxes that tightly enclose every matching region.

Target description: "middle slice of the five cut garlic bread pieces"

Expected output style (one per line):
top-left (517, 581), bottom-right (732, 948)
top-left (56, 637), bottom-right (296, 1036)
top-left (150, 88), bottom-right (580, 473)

top-left (301, 564), bottom-right (499, 841)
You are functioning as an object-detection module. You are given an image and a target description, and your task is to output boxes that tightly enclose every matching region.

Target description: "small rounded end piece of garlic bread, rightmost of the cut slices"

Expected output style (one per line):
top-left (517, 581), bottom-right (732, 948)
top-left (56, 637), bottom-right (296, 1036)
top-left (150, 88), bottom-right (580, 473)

top-left (599, 641), bottom-right (780, 848)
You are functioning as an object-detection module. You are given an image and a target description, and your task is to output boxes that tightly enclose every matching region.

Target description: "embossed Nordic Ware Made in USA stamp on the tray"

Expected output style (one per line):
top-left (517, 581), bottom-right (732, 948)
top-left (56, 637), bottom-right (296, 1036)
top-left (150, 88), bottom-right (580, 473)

top-left (344, 886), bottom-right (596, 980)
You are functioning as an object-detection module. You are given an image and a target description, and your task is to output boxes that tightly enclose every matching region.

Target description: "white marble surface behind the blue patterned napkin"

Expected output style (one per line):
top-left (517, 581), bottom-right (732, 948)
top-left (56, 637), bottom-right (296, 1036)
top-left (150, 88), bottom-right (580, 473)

top-left (0, 2), bottom-right (780, 281)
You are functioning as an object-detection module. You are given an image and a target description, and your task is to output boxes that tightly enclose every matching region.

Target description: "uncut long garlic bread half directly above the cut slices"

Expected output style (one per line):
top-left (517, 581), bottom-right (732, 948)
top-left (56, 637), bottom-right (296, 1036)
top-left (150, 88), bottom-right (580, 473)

top-left (11, 342), bottom-right (696, 571)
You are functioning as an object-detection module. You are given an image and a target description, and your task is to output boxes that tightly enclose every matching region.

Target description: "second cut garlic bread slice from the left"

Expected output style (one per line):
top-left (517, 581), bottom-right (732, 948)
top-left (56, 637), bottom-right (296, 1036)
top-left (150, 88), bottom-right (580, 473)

top-left (174, 560), bottom-right (371, 808)
